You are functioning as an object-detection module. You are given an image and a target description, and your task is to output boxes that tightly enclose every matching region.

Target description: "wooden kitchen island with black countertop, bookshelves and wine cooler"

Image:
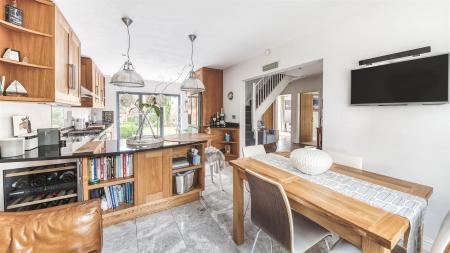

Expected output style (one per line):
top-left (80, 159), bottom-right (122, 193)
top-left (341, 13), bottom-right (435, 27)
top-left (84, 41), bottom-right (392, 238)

top-left (0, 135), bottom-right (207, 226)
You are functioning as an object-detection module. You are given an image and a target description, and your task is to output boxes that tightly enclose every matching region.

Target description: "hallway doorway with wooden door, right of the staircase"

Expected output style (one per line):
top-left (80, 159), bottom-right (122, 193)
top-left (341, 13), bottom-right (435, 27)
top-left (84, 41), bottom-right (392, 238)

top-left (299, 91), bottom-right (322, 148)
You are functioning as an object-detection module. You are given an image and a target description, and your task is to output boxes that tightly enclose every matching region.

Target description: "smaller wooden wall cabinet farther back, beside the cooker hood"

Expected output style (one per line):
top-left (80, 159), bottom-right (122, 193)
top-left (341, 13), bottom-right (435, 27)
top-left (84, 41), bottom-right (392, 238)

top-left (81, 57), bottom-right (105, 108)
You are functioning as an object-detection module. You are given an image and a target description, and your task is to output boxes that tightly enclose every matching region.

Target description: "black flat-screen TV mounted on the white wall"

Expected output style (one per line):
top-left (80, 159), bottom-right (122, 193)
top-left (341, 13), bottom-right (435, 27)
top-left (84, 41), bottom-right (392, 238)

top-left (351, 54), bottom-right (449, 105)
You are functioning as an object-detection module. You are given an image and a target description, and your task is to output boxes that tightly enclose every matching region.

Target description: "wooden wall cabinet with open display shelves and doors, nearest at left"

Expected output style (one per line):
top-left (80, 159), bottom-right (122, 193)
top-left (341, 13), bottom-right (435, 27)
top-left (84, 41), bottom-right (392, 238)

top-left (0, 0), bottom-right (80, 105)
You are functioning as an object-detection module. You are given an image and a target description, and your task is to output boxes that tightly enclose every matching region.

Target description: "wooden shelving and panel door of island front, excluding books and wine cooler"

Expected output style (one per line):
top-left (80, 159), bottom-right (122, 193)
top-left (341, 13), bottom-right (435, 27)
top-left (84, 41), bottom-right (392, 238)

top-left (81, 142), bottom-right (206, 226)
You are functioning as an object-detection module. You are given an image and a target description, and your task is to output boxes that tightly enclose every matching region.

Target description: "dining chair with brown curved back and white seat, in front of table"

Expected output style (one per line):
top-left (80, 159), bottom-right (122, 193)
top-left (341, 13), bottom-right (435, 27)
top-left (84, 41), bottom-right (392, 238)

top-left (245, 170), bottom-right (331, 253)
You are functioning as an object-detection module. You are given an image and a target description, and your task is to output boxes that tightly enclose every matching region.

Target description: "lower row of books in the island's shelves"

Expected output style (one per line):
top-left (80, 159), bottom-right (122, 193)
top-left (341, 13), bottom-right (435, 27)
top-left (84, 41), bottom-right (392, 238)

top-left (89, 182), bottom-right (134, 209)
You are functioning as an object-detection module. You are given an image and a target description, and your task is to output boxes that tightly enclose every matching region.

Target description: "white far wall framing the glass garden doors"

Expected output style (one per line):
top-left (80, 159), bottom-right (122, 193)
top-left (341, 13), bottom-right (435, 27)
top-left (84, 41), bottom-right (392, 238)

top-left (103, 77), bottom-right (187, 138)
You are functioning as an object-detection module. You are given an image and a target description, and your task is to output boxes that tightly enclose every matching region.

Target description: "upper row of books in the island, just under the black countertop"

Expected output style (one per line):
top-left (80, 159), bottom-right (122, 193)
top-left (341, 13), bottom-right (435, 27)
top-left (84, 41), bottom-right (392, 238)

top-left (88, 154), bottom-right (133, 184)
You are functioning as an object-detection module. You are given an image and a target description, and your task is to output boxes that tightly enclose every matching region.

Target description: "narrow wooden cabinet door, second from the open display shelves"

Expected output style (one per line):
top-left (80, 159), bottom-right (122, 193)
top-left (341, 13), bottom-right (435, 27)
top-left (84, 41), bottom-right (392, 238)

top-left (69, 32), bottom-right (81, 101)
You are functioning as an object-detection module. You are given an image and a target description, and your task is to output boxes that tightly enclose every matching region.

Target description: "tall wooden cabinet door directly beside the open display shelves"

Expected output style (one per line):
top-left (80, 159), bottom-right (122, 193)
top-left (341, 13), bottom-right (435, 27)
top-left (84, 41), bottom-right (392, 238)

top-left (55, 9), bottom-right (70, 100)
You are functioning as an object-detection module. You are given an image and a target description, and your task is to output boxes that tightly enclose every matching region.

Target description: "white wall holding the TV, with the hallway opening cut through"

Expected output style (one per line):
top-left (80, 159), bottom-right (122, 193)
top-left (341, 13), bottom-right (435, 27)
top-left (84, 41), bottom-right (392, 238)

top-left (223, 0), bottom-right (450, 245)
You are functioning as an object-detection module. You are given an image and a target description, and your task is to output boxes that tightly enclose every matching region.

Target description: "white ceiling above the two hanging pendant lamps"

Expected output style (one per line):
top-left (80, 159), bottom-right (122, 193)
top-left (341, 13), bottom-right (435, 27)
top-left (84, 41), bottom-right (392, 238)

top-left (56, 0), bottom-right (388, 81)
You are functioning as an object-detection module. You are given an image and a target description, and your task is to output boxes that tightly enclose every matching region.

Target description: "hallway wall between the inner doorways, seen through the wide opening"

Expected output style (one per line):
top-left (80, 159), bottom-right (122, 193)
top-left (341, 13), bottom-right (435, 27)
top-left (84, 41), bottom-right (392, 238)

top-left (281, 74), bottom-right (323, 143)
